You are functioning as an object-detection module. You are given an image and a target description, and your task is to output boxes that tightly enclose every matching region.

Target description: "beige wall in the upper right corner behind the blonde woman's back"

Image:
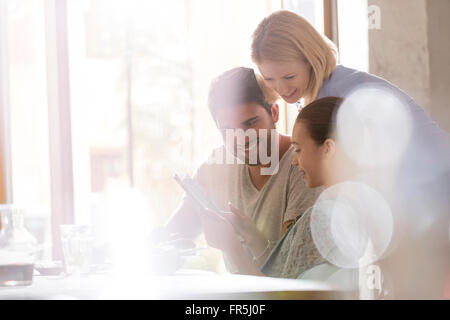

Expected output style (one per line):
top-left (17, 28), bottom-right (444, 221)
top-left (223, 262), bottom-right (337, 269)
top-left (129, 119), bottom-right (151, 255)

top-left (368, 0), bottom-right (450, 132)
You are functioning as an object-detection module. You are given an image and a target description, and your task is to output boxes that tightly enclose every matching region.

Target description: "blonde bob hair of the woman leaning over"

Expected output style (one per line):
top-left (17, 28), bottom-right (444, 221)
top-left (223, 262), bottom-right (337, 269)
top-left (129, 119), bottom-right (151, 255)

top-left (251, 10), bottom-right (337, 104)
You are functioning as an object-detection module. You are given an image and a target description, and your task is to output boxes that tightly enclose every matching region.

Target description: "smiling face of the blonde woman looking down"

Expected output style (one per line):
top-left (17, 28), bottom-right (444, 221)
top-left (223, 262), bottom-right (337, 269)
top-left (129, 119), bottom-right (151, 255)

top-left (258, 60), bottom-right (311, 103)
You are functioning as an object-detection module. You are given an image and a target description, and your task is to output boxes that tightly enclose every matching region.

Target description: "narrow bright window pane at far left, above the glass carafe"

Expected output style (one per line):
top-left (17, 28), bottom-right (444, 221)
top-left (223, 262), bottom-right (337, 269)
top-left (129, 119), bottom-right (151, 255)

top-left (8, 0), bottom-right (51, 258)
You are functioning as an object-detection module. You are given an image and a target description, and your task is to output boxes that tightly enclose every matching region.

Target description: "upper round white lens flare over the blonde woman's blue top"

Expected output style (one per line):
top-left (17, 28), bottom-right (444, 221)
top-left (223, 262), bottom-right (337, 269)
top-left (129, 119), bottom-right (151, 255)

top-left (336, 86), bottom-right (412, 166)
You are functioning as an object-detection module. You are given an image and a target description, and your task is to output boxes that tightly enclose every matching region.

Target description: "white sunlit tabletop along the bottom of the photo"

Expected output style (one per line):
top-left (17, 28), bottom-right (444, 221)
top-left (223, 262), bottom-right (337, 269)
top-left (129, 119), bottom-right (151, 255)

top-left (0, 270), bottom-right (352, 300)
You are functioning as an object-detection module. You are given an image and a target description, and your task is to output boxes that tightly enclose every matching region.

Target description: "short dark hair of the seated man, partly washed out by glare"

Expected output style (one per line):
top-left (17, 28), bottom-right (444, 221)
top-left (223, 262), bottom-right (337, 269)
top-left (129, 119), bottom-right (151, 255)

top-left (208, 67), bottom-right (279, 120)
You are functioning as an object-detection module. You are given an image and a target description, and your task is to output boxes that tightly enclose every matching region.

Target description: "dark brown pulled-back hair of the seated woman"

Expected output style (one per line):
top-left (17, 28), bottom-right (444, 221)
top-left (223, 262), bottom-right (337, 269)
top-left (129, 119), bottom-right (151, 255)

top-left (295, 97), bottom-right (343, 145)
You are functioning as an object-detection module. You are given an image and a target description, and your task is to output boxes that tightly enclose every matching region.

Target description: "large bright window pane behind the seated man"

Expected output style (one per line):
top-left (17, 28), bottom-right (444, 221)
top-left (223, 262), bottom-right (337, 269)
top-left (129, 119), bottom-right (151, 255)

top-left (68, 0), bottom-right (267, 258)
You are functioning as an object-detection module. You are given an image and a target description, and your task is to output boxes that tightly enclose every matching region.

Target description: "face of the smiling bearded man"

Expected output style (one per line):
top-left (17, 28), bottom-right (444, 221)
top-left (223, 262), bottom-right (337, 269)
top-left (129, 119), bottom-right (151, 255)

top-left (216, 103), bottom-right (278, 165)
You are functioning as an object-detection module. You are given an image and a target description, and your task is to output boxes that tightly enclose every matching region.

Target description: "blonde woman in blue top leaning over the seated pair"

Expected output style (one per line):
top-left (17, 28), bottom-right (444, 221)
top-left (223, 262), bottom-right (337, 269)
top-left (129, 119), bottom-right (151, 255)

top-left (251, 10), bottom-right (450, 298)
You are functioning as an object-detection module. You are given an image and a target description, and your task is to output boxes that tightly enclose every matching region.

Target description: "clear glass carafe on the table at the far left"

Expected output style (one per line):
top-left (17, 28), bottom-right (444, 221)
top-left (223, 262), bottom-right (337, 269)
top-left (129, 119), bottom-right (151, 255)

top-left (0, 205), bottom-right (37, 286)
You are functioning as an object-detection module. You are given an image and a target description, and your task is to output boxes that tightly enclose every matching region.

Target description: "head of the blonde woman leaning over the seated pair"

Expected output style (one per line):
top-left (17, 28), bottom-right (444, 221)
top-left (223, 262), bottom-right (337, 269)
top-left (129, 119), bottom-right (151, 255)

top-left (251, 10), bottom-right (336, 105)
